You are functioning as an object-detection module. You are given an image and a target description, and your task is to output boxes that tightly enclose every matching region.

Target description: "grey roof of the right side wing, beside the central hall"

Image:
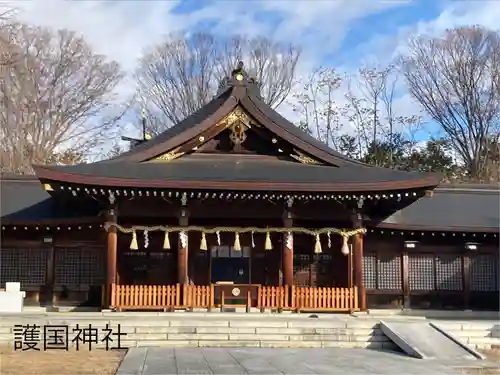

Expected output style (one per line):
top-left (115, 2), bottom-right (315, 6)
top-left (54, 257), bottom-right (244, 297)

top-left (381, 185), bottom-right (500, 231)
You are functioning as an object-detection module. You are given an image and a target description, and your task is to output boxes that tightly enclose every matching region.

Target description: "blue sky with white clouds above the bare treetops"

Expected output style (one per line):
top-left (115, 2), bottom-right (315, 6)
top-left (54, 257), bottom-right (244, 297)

top-left (7, 0), bottom-right (500, 149)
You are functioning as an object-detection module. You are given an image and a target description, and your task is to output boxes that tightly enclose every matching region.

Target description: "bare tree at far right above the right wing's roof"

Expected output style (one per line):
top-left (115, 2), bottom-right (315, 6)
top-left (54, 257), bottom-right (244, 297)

top-left (402, 26), bottom-right (500, 180)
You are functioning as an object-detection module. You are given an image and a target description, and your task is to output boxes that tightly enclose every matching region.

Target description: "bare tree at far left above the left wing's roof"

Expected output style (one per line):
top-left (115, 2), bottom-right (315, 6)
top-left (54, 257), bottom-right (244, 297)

top-left (0, 24), bottom-right (121, 173)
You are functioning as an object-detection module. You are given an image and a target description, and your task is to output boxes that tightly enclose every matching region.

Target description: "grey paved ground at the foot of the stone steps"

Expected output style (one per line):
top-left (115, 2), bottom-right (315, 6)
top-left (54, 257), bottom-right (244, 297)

top-left (117, 348), bottom-right (488, 375)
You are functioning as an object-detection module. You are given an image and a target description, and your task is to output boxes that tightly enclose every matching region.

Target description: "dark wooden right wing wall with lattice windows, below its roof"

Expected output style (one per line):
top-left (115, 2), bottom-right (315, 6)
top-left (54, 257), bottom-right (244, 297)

top-left (363, 234), bottom-right (500, 310)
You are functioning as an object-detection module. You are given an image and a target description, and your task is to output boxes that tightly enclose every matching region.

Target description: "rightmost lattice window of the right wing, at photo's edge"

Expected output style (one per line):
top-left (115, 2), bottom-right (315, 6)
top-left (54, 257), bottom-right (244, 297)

top-left (470, 254), bottom-right (499, 292)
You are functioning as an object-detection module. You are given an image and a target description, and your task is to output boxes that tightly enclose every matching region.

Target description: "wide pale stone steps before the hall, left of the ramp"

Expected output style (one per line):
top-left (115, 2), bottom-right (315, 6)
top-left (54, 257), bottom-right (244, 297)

top-left (0, 313), bottom-right (396, 350)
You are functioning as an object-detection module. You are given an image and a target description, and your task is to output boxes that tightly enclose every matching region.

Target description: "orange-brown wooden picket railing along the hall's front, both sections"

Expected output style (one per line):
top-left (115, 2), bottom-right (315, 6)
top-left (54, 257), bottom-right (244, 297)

top-left (111, 284), bottom-right (359, 312)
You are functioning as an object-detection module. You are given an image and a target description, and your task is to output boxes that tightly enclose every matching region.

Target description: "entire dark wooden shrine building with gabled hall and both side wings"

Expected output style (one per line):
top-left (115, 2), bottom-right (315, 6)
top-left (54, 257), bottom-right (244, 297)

top-left (0, 63), bottom-right (499, 311)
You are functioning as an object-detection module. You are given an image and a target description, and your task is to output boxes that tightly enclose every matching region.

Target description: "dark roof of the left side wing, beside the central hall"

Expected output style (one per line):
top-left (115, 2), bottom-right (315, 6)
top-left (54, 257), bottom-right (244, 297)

top-left (0, 176), bottom-right (97, 224)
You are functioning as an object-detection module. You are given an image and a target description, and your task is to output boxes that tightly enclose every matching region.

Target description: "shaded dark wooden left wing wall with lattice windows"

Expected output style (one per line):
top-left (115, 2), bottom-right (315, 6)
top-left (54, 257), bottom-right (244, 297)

top-left (0, 229), bottom-right (106, 306)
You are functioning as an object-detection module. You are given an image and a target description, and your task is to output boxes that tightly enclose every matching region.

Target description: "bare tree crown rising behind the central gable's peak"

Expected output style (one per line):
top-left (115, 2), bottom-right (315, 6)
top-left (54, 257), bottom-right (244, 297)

top-left (136, 33), bottom-right (300, 133)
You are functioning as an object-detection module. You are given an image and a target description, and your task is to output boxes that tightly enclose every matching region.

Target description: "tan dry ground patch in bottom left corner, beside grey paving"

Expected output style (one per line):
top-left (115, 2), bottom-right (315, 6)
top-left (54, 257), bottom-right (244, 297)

top-left (0, 346), bottom-right (126, 375)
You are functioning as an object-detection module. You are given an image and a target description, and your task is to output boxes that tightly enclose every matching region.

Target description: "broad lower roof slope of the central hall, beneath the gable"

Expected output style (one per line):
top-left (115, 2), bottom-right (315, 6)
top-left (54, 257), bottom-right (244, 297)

top-left (35, 154), bottom-right (436, 190)
